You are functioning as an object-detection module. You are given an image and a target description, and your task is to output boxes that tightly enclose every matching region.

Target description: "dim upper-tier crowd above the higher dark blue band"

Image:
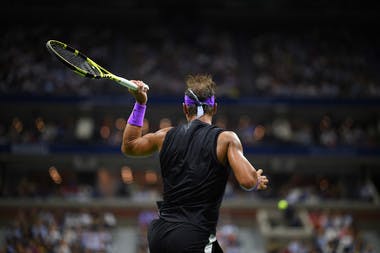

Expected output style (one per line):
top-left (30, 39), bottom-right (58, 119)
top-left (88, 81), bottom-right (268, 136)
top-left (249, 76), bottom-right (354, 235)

top-left (0, 23), bottom-right (380, 98)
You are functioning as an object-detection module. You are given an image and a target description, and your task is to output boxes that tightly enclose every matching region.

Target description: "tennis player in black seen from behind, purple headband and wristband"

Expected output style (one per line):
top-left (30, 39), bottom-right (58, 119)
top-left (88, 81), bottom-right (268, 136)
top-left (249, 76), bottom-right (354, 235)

top-left (121, 75), bottom-right (268, 253)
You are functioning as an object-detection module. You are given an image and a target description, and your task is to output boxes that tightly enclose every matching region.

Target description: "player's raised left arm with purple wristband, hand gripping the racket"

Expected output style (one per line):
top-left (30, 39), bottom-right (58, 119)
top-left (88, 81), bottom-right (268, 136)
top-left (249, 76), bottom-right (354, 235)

top-left (121, 80), bottom-right (170, 156)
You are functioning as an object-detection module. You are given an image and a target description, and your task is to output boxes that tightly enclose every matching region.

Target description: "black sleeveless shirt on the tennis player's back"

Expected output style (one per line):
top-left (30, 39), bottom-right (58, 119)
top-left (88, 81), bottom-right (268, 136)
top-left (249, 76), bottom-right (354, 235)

top-left (157, 120), bottom-right (230, 234)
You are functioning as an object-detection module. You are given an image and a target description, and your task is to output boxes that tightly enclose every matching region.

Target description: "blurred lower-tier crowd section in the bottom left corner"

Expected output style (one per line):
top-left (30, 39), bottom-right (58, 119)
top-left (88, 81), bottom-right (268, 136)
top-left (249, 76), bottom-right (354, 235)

top-left (0, 208), bottom-right (117, 253)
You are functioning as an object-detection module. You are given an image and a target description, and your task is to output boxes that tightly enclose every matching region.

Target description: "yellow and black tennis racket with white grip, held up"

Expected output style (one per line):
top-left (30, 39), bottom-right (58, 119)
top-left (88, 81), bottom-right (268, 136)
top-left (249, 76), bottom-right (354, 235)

top-left (46, 40), bottom-right (149, 90)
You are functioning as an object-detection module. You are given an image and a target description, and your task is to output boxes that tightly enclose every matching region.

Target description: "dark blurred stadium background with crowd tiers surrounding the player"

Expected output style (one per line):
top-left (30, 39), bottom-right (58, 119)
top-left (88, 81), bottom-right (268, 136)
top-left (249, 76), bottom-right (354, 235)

top-left (0, 0), bottom-right (380, 253)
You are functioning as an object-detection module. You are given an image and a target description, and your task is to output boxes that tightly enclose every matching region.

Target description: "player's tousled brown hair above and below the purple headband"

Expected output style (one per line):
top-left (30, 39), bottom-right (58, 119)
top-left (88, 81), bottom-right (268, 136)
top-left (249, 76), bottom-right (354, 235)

top-left (185, 74), bottom-right (216, 115)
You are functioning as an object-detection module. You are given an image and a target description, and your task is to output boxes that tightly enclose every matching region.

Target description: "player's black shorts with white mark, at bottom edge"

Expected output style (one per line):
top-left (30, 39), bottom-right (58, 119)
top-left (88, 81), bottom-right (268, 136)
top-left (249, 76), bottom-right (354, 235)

top-left (148, 219), bottom-right (223, 253)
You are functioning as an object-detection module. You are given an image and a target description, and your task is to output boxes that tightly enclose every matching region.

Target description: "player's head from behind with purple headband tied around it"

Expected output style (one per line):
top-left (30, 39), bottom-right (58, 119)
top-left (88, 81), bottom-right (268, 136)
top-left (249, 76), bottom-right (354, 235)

top-left (183, 74), bottom-right (216, 118)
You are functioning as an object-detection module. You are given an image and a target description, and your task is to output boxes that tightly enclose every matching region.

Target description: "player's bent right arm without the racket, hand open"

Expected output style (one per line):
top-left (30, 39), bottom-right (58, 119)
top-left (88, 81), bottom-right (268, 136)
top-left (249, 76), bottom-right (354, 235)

top-left (217, 131), bottom-right (269, 190)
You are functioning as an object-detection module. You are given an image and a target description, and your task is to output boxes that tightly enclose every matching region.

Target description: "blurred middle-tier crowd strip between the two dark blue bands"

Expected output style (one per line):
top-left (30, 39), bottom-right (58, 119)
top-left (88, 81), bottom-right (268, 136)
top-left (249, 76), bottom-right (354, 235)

top-left (0, 112), bottom-right (380, 149)
